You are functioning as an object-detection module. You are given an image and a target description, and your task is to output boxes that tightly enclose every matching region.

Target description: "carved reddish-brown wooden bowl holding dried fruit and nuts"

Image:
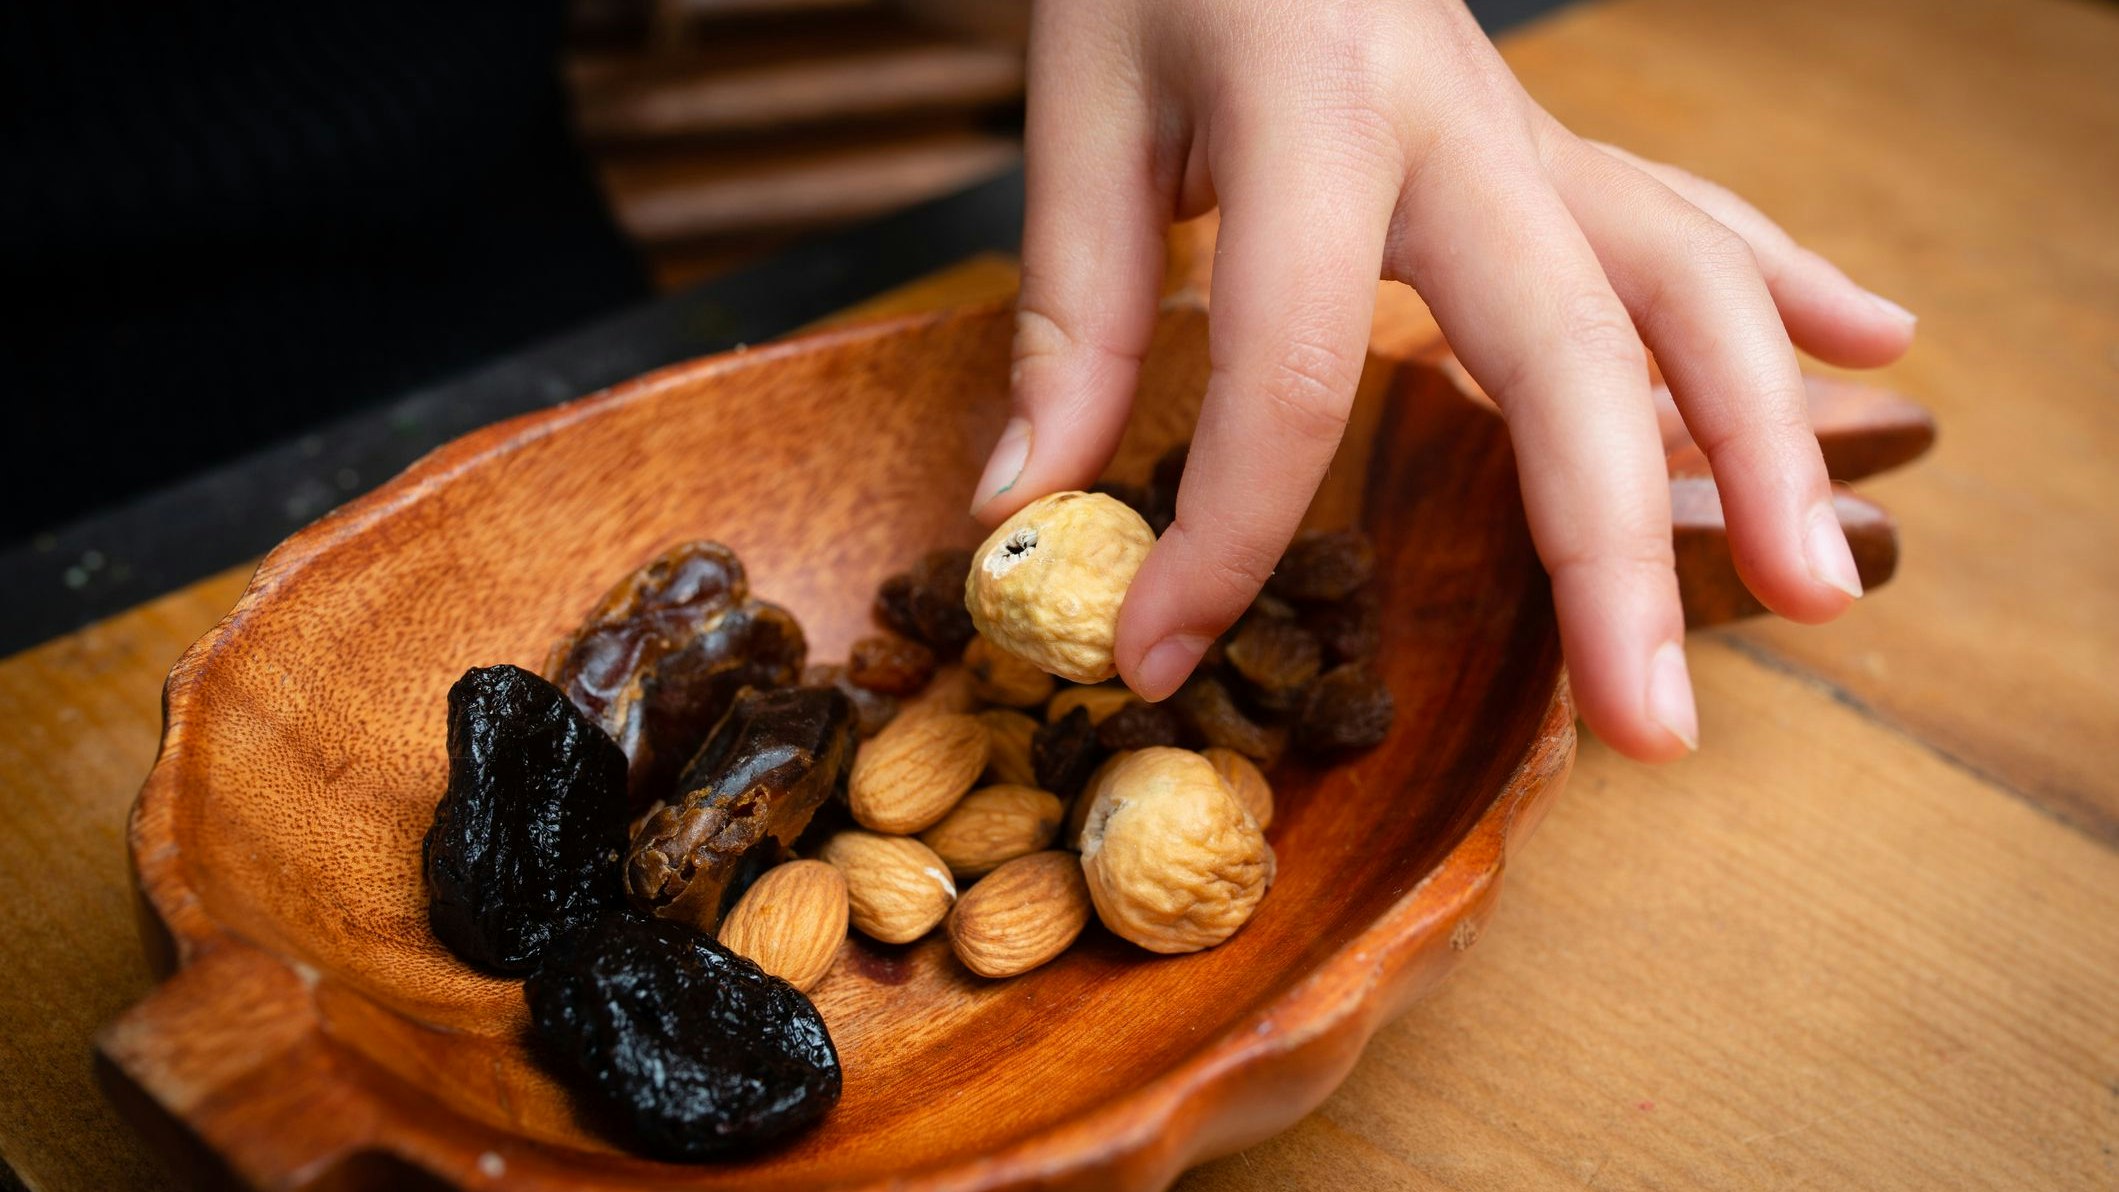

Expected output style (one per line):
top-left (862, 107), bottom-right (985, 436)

top-left (100, 303), bottom-right (1574, 1190)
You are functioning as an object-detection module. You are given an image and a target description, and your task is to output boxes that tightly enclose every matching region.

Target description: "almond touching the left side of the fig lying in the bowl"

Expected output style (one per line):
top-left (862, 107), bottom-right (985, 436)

top-left (949, 851), bottom-right (1089, 976)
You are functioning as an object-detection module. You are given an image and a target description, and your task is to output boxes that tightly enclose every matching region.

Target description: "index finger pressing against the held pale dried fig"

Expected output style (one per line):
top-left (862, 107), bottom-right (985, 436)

top-left (1115, 121), bottom-right (1396, 699)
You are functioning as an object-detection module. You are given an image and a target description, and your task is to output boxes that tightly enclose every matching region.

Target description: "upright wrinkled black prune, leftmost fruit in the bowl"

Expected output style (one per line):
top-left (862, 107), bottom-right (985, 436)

top-left (420, 667), bottom-right (625, 972)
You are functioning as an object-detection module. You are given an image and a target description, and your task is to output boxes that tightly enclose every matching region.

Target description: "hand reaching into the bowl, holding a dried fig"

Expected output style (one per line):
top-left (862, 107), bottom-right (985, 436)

top-left (973, 0), bottom-right (1913, 760)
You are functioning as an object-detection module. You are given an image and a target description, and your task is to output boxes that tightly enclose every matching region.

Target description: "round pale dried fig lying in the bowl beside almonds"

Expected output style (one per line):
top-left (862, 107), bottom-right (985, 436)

top-left (1081, 747), bottom-right (1269, 953)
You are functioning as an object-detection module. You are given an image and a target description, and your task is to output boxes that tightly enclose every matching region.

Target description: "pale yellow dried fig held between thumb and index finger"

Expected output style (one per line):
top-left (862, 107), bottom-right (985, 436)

top-left (964, 493), bottom-right (1155, 684)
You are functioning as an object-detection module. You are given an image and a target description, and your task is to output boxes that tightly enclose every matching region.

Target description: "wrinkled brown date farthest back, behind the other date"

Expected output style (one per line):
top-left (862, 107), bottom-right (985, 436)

top-left (545, 542), bottom-right (807, 807)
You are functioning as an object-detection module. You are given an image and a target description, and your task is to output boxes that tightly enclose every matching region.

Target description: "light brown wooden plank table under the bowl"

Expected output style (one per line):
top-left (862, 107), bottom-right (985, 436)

top-left (0, 0), bottom-right (2119, 1192)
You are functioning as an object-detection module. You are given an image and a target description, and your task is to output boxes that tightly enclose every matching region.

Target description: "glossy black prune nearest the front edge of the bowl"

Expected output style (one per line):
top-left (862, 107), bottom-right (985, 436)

top-left (523, 910), bottom-right (841, 1160)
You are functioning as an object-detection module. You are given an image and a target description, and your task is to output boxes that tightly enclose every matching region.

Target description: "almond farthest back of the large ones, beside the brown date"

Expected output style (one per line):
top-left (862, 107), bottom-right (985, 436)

top-left (845, 714), bottom-right (992, 834)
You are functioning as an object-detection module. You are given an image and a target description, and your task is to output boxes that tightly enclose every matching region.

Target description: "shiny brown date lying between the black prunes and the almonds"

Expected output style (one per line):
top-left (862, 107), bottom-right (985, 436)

top-left (625, 688), bottom-right (854, 932)
